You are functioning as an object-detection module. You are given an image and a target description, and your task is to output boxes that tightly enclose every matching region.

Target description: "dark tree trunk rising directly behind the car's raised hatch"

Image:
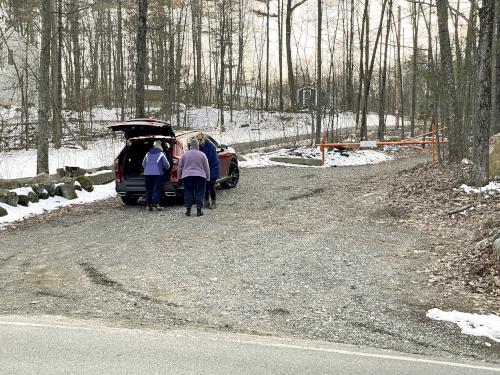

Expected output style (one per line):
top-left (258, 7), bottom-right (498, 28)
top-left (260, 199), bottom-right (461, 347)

top-left (135, 0), bottom-right (148, 118)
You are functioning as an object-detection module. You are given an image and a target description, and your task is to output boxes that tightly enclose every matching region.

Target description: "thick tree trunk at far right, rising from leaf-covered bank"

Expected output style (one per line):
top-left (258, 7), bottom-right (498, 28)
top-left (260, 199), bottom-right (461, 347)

top-left (470, 0), bottom-right (495, 186)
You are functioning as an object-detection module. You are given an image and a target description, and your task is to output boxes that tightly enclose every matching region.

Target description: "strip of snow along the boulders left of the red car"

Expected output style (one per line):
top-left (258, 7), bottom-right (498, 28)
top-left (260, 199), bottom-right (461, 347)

top-left (0, 181), bottom-right (116, 229)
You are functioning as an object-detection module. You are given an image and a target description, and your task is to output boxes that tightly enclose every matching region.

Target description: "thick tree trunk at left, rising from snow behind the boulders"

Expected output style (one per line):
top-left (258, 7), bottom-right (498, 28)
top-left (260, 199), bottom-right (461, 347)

top-left (36, 0), bottom-right (52, 174)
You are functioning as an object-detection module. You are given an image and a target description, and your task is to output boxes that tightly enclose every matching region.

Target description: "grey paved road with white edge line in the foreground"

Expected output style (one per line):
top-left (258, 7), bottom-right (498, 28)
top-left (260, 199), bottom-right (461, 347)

top-left (0, 316), bottom-right (500, 375)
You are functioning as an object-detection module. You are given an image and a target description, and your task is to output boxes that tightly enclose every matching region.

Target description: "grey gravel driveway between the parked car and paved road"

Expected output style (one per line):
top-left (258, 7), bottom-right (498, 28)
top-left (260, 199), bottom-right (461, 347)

top-left (0, 159), bottom-right (500, 362)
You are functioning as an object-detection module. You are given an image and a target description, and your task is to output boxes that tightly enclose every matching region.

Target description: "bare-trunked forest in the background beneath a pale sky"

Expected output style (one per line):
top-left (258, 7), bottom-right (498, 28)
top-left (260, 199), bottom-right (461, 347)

top-left (0, 0), bottom-right (500, 184)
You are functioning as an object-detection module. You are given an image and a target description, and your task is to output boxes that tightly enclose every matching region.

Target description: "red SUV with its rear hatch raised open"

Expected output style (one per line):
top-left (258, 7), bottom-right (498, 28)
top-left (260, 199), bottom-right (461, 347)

top-left (109, 119), bottom-right (240, 204)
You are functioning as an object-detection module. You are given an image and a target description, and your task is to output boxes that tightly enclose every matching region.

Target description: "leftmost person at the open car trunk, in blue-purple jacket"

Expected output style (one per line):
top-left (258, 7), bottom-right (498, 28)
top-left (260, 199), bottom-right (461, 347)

top-left (142, 141), bottom-right (170, 211)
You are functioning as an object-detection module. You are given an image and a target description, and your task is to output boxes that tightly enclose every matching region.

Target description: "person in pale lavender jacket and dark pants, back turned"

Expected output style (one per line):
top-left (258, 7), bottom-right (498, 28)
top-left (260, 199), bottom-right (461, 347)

top-left (178, 138), bottom-right (210, 216)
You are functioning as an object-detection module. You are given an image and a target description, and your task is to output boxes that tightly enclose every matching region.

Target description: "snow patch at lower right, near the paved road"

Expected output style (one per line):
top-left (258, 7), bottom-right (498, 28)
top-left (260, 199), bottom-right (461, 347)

top-left (426, 309), bottom-right (500, 342)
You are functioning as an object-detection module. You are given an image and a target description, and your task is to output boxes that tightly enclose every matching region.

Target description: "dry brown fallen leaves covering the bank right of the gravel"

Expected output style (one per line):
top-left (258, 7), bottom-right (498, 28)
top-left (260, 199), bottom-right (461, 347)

top-left (388, 163), bottom-right (500, 311)
